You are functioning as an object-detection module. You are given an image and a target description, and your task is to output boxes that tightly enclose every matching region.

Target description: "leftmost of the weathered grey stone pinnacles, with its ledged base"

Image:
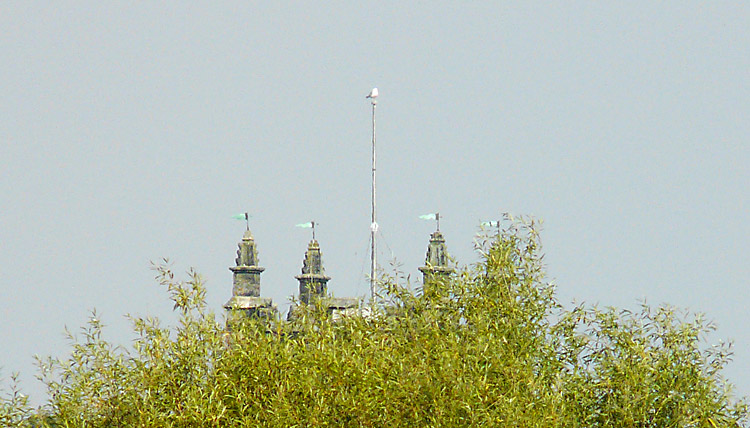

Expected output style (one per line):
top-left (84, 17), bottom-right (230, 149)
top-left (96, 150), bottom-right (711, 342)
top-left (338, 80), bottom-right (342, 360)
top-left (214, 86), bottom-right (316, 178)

top-left (224, 229), bottom-right (277, 317)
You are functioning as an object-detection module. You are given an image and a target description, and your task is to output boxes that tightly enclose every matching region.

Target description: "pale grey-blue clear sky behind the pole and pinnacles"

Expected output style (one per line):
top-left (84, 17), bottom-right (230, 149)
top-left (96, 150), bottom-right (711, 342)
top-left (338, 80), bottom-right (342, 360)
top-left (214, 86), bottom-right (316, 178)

top-left (0, 0), bottom-right (750, 403)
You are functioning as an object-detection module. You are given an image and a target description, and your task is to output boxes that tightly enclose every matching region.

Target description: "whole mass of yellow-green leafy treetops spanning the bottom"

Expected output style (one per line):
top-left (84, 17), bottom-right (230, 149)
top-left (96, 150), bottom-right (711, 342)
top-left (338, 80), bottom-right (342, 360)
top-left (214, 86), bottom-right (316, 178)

top-left (0, 219), bottom-right (747, 427)
